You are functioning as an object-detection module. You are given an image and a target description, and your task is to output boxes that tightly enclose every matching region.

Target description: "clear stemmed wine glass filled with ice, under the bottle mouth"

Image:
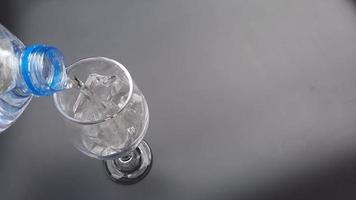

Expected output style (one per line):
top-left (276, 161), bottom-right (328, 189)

top-left (54, 57), bottom-right (152, 184)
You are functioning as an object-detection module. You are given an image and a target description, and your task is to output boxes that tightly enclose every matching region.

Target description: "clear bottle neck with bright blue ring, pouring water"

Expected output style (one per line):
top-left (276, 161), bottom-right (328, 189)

top-left (20, 45), bottom-right (69, 96)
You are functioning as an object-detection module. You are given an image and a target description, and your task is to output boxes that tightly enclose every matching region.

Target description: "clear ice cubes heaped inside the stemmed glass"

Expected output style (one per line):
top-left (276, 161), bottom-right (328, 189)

top-left (73, 74), bottom-right (136, 155)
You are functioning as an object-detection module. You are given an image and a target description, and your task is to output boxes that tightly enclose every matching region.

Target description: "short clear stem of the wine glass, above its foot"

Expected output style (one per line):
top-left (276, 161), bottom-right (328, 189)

top-left (114, 150), bottom-right (141, 172)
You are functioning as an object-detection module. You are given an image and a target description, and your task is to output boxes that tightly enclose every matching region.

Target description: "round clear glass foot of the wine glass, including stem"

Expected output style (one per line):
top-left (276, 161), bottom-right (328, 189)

top-left (103, 140), bottom-right (152, 185)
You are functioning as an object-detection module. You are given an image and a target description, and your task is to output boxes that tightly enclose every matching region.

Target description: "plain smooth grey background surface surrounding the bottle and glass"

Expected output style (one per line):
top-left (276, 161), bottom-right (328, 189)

top-left (0, 0), bottom-right (356, 200)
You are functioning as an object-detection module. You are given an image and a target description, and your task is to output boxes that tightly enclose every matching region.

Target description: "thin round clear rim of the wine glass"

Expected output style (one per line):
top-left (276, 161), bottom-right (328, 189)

top-left (53, 57), bottom-right (134, 125)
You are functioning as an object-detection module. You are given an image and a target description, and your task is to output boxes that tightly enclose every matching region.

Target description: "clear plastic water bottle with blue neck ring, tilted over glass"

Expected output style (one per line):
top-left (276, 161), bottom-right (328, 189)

top-left (0, 24), bottom-right (70, 133)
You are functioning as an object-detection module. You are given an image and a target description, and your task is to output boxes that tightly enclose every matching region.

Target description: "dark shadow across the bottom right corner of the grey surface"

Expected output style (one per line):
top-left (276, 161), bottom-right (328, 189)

top-left (219, 156), bottom-right (356, 200)
